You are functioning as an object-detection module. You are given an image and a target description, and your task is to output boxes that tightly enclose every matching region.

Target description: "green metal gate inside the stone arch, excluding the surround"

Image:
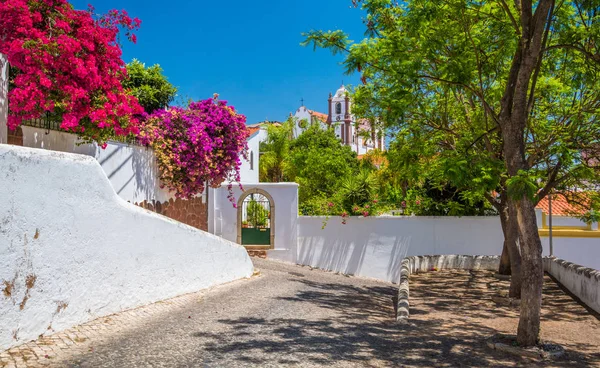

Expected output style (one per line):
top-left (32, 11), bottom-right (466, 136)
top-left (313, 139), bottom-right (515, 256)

top-left (242, 193), bottom-right (271, 245)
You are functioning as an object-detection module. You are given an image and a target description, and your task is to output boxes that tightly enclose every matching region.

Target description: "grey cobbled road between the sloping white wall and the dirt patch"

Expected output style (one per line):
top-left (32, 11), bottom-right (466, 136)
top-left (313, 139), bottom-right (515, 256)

top-left (7, 259), bottom-right (398, 367)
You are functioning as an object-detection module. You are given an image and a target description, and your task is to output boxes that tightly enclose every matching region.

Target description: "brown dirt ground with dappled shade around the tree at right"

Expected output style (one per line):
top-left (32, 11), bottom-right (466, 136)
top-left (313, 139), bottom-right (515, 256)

top-left (409, 271), bottom-right (600, 367)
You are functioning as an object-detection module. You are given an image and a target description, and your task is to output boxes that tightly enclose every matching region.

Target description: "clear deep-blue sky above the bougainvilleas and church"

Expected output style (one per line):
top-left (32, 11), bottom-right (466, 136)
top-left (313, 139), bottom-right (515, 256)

top-left (72, 0), bottom-right (364, 124)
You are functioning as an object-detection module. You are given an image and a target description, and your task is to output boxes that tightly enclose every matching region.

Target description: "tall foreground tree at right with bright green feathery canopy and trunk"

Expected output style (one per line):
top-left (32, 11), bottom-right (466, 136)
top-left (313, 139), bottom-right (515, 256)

top-left (307, 0), bottom-right (600, 346)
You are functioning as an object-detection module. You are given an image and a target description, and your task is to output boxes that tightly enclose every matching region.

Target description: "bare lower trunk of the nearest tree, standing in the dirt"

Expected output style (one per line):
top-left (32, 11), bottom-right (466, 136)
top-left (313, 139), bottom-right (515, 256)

top-left (516, 197), bottom-right (544, 346)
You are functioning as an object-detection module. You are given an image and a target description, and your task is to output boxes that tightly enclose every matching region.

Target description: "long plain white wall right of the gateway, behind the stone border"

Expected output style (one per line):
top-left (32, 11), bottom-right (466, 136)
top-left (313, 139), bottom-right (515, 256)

top-left (297, 216), bottom-right (504, 282)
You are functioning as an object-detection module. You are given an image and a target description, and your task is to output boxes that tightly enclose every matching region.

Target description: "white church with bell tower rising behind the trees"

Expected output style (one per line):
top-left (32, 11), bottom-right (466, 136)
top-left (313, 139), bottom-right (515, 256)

top-left (293, 86), bottom-right (385, 155)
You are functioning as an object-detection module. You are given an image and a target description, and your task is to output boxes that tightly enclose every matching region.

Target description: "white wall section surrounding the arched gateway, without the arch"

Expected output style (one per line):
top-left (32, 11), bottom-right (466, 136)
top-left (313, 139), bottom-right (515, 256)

top-left (208, 183), bottom-right (298, 262)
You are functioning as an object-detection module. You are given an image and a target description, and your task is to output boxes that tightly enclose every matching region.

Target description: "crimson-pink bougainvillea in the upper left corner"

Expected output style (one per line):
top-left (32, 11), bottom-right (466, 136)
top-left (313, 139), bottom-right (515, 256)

top-left (0, 0), bottom-right (143, 143)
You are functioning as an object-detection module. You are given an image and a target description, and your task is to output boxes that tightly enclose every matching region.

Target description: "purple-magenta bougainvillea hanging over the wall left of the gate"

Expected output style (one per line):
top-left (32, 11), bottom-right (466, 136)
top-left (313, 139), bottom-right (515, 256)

top-left (139, 95), bottom-right (248, 202)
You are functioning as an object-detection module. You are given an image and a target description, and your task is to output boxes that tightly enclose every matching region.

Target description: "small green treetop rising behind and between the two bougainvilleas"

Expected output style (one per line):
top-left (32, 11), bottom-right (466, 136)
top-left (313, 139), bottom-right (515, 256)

top-left (123, 59), bottom-right (177, 114)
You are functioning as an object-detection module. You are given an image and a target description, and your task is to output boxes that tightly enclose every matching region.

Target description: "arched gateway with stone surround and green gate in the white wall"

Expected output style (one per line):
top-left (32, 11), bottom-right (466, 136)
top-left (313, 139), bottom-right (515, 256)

top-left (237, 188), bottom-right (275, 249)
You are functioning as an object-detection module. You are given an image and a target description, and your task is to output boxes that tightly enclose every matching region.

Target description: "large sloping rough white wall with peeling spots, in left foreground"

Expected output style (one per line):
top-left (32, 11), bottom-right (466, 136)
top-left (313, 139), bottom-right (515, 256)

top-left (0, 145), bottom-right (253, 350)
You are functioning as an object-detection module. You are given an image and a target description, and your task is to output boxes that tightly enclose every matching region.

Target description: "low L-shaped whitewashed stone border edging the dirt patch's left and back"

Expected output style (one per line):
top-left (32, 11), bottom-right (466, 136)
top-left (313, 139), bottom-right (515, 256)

top-left (396, 255), bottom-right (500, 322)
